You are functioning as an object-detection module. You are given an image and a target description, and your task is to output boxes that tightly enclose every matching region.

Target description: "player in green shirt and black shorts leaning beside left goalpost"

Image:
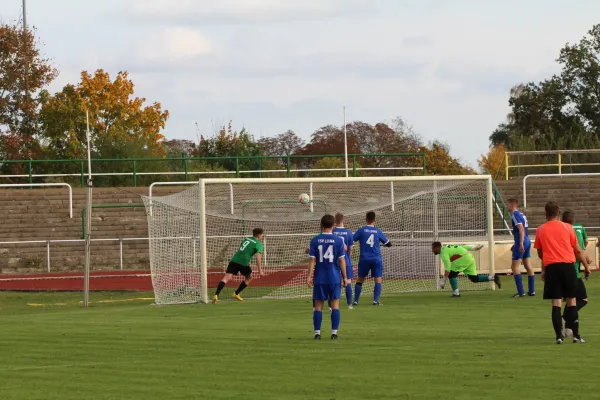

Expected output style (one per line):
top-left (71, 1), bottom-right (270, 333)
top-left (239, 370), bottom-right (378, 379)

top-left (213, 228), bottom-right (263, 304)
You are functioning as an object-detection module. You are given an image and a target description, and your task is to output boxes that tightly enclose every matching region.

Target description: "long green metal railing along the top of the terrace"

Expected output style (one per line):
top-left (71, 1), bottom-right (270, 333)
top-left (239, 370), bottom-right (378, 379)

top-left (0, 153), bottom-right (427, 187)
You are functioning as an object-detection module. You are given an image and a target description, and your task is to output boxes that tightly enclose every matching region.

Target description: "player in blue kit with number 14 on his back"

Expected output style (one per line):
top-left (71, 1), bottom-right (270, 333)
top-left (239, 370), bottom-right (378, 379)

top-left (307, 214), bottom-right (346, 340)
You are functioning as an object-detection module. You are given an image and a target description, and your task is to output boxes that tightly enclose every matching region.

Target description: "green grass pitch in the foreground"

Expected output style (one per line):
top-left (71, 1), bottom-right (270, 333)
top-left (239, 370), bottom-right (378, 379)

top-left (0, 276), bottom-right (600, 400)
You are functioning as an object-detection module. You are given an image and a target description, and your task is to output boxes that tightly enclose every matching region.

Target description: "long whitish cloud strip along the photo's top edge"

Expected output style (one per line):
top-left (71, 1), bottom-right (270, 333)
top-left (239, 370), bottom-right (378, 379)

top-left (127, 0), bottom-right (373, 24)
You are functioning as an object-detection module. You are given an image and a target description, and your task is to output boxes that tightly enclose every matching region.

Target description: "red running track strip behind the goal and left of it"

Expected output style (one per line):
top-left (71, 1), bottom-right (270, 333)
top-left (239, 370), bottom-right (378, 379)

top-left (0, 267), bottom-right (306, 292)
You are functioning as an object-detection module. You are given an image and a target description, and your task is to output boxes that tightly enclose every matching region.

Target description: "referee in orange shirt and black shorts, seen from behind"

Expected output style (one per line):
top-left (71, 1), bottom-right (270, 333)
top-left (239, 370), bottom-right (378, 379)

top-left (533, 201), bottom-right (587, 344)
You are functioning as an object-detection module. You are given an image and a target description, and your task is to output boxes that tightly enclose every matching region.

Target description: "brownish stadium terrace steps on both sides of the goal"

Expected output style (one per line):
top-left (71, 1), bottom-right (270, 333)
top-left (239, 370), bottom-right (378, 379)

top-left (0, 178), bottom-right (600, 274)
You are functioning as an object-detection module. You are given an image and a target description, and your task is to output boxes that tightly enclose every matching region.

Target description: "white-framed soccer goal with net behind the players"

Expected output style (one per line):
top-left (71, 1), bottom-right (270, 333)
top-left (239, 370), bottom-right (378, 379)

top-left (144, 175), bottom-right (494, 304)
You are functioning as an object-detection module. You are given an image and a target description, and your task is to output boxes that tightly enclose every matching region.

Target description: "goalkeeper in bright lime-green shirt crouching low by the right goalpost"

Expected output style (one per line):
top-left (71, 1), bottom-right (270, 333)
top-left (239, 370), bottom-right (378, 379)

top-left (431, 242), bottom-right (502, 297)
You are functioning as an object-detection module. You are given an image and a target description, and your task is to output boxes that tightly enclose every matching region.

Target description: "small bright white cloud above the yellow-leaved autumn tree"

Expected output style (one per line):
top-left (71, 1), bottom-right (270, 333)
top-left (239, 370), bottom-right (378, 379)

top-left (138, 27), bottom-right (213, 64)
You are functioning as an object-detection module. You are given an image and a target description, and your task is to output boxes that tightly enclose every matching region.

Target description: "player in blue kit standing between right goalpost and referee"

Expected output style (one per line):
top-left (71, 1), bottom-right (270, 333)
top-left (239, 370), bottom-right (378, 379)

top-left (506, 199), bottom-right (535, 297)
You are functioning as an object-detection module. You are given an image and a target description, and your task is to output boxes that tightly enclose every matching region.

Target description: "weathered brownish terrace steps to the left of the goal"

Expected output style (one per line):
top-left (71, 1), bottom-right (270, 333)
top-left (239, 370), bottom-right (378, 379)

top-left (0, 187), bottom-right (184, 274)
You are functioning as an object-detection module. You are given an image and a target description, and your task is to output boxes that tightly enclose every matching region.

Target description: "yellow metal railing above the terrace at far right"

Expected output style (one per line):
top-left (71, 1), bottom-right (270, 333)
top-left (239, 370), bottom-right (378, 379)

top-left (503, 149), bottom-right (600, 180)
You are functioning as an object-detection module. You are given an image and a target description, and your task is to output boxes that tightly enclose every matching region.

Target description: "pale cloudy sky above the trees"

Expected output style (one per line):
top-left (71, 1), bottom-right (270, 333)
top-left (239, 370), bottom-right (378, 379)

top-left (0, 0), bottom-right (600, 166)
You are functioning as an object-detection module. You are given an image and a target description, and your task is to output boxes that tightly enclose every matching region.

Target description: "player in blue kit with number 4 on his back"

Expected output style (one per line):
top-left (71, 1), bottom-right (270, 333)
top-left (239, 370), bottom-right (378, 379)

top-left (353, 211), bottom-right (392, 306)
